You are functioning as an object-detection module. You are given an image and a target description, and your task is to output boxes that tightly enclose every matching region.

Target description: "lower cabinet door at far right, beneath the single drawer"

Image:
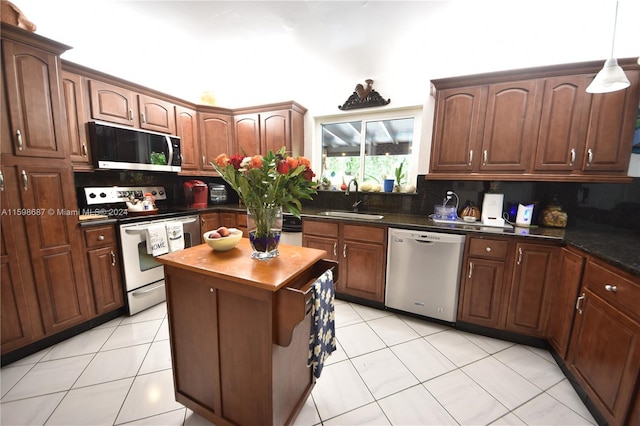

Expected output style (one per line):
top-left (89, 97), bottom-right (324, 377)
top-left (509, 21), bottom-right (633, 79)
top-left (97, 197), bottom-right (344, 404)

top-left (568, 287), bottom-right (640, 425)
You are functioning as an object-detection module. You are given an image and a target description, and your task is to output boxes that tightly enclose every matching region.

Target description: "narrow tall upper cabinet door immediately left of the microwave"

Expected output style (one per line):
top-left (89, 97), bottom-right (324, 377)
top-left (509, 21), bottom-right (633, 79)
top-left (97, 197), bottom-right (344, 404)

top-left (62, 71), bottom-right (93, 170)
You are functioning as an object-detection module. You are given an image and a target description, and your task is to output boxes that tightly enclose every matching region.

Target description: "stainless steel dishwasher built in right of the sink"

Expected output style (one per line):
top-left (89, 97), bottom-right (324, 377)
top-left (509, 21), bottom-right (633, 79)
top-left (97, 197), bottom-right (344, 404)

top-left (385, 228), bottom-right (465, 323)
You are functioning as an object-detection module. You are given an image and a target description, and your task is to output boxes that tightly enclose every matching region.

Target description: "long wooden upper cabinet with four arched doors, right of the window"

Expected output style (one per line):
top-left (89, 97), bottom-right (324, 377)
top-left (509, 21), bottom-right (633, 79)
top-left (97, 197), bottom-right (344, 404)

top-left (427, 59), bottom-right (640, 182)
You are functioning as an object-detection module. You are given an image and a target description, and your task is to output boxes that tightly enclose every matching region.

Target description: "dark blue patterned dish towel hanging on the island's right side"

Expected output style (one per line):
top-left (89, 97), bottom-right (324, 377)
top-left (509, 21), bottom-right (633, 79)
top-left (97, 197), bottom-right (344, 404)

top-left (307, 269), bottom-right (336, 378)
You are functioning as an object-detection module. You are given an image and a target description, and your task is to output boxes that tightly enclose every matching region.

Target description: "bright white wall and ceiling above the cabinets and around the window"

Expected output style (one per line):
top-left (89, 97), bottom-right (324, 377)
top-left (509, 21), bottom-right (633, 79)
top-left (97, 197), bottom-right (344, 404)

top-left (14, 0), bottom-right (640, 173)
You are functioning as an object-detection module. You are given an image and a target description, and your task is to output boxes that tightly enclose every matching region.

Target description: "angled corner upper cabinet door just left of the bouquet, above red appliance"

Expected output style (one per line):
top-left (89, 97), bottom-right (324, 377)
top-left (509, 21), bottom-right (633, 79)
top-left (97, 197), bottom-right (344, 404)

top-left (199, 113), bottom-right (235, 172)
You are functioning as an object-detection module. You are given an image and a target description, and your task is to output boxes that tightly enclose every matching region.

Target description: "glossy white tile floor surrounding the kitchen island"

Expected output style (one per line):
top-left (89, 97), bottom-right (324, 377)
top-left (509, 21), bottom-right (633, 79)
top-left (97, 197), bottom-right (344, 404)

top-left (0, 301), bottom-right (595, 425)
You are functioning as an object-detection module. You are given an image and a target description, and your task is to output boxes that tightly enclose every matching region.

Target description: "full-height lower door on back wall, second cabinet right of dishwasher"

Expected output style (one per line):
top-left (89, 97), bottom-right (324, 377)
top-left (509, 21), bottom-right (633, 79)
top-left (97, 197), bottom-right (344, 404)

top-left (506, 243), bottom-right (558, 336)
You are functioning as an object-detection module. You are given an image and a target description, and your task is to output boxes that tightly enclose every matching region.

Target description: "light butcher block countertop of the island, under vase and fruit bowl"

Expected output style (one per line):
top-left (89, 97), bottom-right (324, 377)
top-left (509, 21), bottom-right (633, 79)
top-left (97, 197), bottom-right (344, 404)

top-left (156, 238), bottom-right (327, 292)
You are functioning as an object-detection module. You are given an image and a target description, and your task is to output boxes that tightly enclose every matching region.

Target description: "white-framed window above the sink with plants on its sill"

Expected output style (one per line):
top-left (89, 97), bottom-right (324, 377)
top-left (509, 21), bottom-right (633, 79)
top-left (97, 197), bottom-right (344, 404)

top-left (317, 109), bottom-right (420, 190)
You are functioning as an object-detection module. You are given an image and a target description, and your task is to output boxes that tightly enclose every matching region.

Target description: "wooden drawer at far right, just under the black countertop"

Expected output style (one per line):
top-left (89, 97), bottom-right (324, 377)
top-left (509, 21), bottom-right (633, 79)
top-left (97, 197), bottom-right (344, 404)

top-left (583, 259), bottom-right (640, 320)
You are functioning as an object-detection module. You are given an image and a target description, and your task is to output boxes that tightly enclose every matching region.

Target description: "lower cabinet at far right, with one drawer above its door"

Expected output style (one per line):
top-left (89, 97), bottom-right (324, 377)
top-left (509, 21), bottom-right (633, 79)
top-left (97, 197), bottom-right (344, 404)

top-left (567, 259), bottom-right (640, 425)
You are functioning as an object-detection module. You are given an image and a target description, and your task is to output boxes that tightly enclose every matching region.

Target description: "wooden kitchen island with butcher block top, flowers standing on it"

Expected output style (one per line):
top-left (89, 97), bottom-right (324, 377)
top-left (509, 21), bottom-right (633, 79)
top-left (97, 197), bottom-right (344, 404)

top-left (157, 238), bottom-right (337, 425)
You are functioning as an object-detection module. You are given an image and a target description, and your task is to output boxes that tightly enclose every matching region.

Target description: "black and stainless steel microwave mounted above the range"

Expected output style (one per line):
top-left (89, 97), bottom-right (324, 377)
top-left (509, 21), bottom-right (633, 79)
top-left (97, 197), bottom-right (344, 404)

top-left (89, 121), bottom-right (182, 172)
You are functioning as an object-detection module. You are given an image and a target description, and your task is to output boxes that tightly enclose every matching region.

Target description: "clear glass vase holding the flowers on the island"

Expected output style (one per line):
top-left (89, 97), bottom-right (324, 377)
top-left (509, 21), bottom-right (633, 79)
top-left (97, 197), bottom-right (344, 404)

top-left (247, 206), bottom-right (282, 260)
